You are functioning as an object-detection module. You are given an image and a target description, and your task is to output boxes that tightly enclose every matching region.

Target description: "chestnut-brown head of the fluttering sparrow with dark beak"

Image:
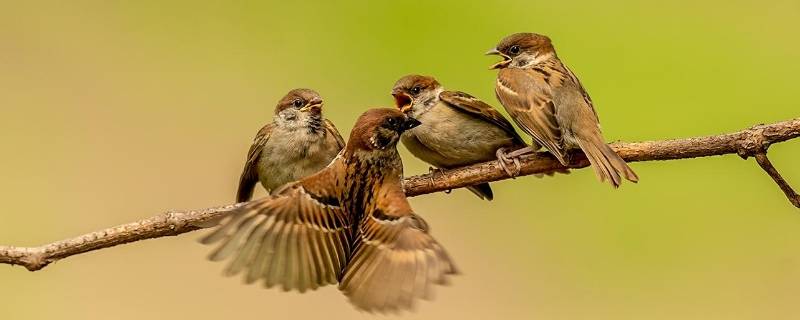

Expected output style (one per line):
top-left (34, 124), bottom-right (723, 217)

top-left (347, 108), bottom-right (420, 151)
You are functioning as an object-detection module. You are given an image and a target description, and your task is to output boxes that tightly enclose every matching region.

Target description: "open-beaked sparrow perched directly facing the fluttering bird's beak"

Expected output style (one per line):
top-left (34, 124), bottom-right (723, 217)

top-left (392, 75), bottom-right (539, 200)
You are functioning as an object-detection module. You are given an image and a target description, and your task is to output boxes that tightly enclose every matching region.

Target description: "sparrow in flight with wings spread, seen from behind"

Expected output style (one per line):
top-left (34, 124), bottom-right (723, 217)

top-left (202, 109), bottom-right (456, 311)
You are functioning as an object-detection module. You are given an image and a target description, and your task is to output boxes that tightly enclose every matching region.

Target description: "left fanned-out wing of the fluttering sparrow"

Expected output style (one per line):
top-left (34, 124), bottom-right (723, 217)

top-left (201, 174), bottom-right (351, 292)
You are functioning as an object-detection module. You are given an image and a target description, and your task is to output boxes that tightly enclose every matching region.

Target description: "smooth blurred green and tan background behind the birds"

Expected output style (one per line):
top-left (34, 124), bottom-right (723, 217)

top-left (0, 0), bottom-right (800, 319)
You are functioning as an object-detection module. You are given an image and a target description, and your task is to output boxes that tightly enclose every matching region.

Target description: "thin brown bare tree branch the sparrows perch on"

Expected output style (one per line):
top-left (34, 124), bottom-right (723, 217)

top-left (0, 118), bottom-right (800, 271)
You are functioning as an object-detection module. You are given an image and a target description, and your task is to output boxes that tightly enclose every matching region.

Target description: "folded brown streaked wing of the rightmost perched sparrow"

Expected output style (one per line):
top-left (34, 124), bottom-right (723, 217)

top-left (495, 68), bottom-right (566, 165)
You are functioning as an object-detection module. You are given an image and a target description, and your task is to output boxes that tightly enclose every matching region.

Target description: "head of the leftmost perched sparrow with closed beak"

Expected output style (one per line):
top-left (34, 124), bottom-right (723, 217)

top-left (275, 89), bottom-right (322, 127)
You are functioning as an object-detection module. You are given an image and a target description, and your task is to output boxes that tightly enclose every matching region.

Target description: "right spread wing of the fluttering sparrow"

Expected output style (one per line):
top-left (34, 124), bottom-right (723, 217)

top-left (339, 191), bottom-right (457, 312)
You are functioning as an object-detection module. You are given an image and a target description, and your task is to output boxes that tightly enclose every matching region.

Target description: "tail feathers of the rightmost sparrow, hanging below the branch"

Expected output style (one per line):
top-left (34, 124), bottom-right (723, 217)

top-left (576, 134), bottom-right (639, 188)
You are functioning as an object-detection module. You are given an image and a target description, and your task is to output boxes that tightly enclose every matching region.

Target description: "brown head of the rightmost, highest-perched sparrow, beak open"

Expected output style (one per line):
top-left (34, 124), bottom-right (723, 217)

top-left (486, 33), bottom-right (556, 69)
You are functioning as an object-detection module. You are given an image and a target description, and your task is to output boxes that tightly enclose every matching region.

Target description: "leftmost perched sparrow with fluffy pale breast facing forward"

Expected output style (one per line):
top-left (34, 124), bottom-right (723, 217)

top-left (236, 89), bottom-right (344, 202)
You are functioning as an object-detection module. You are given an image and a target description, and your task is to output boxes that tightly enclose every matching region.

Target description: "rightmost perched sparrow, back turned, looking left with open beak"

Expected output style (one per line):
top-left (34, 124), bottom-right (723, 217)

top-left (487, 33), bottom-right (639, 187)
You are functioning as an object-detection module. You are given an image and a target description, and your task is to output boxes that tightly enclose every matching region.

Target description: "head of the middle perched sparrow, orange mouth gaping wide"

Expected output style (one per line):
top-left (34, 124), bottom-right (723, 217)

top-left (392, 75), bottom-right (443, 116)
